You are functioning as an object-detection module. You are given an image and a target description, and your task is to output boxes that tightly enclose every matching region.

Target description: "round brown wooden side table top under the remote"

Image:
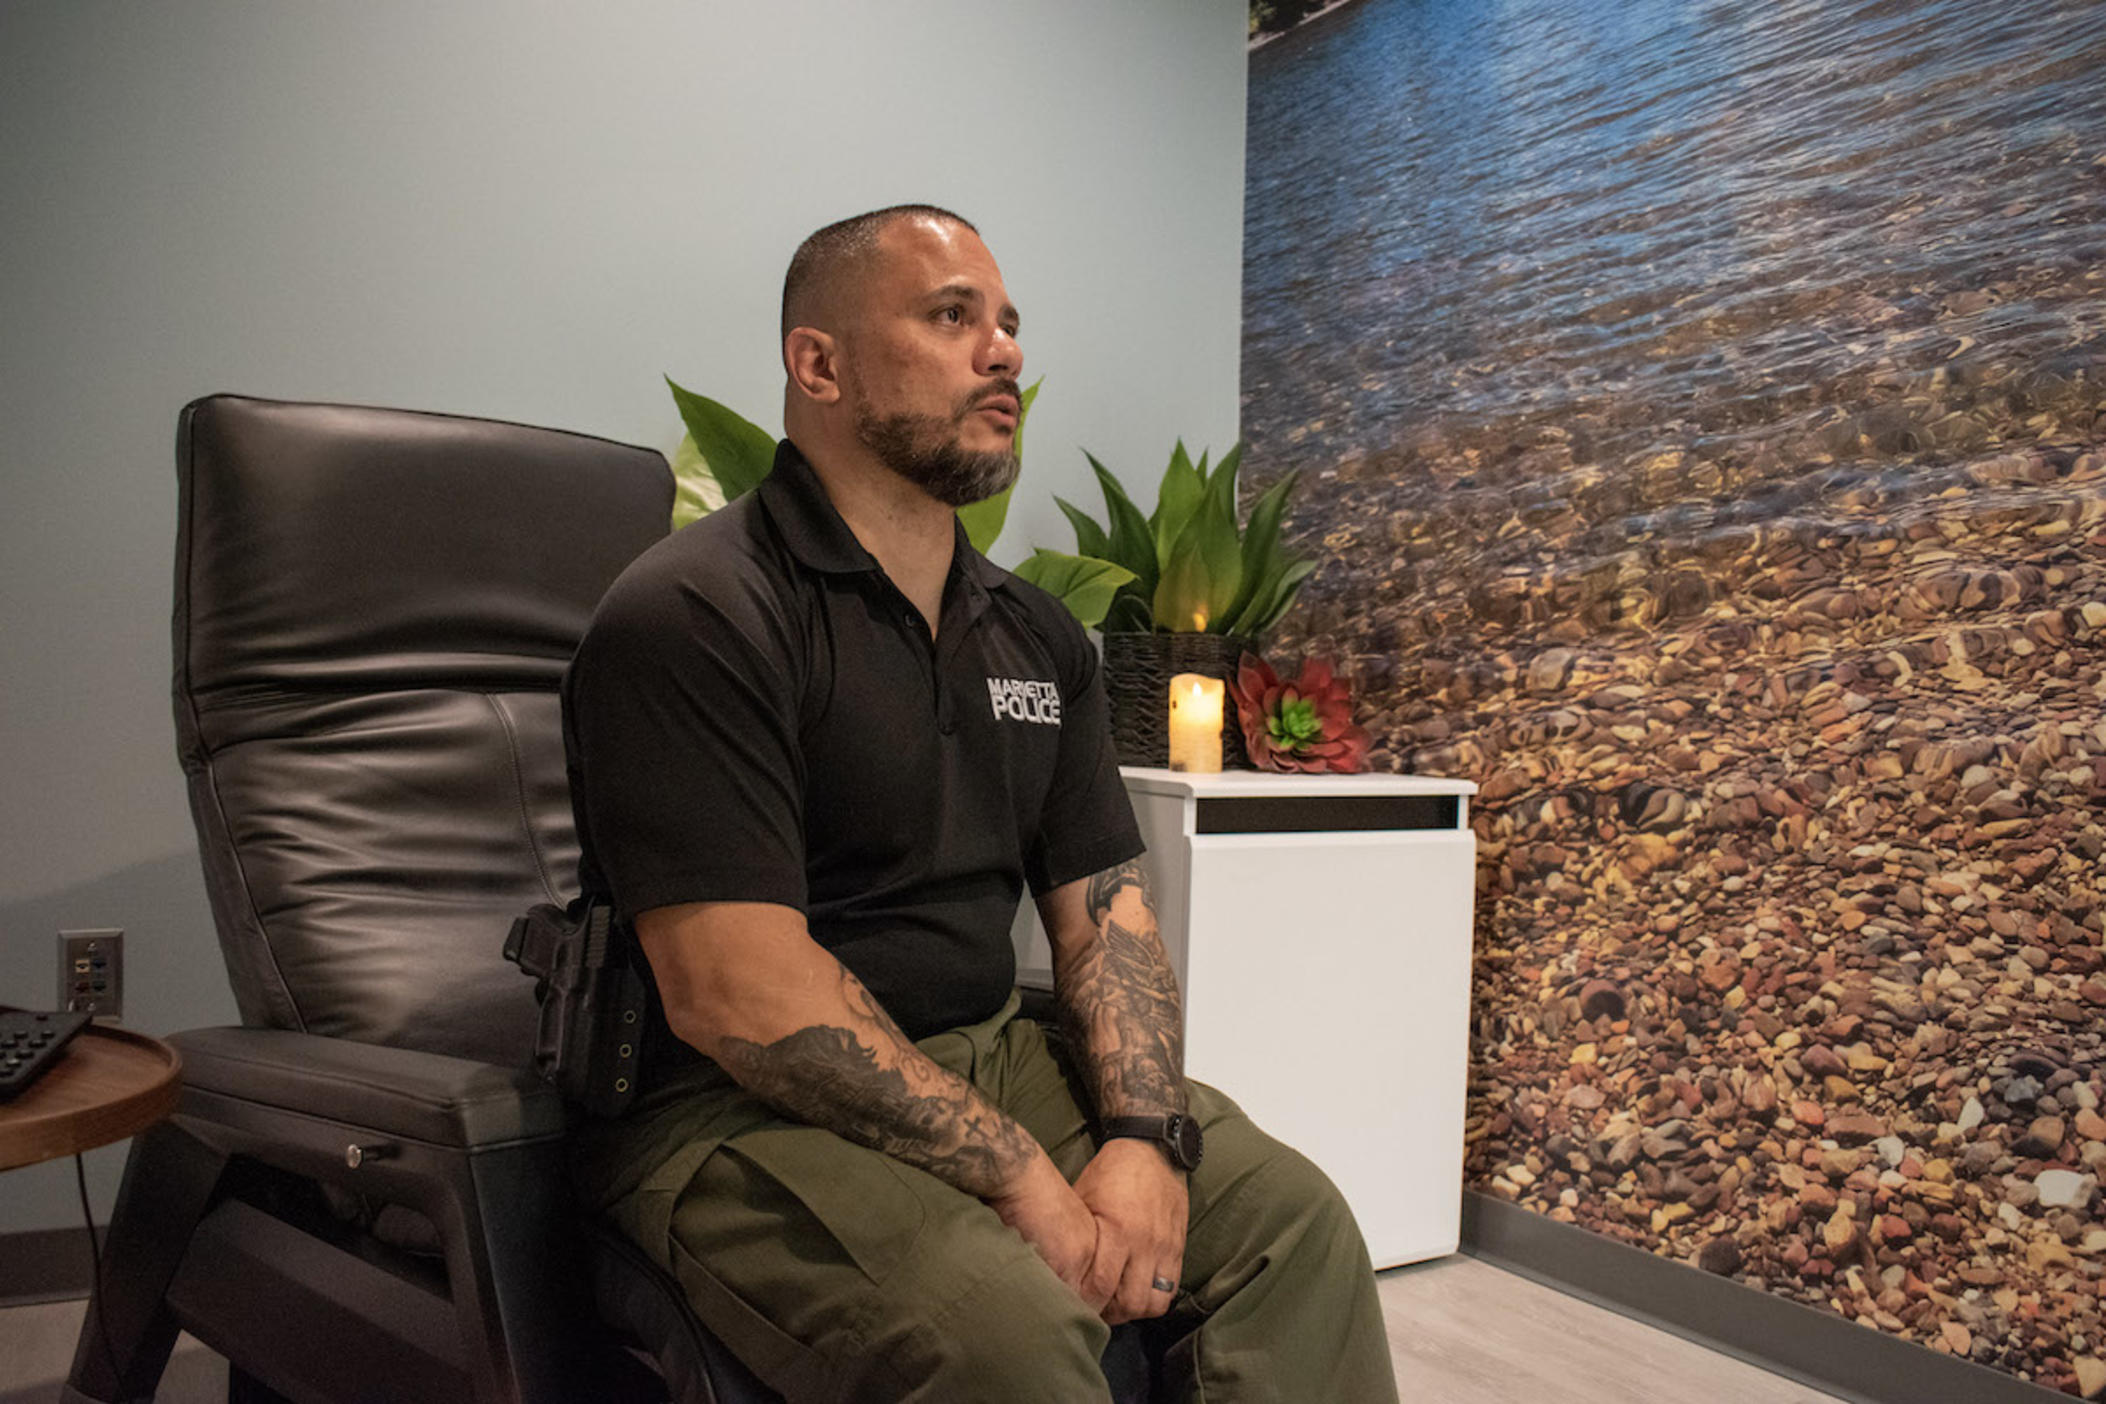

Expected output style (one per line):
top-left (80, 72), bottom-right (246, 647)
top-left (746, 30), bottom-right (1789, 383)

top-left (0, 1023), bottom-right (183, 1170)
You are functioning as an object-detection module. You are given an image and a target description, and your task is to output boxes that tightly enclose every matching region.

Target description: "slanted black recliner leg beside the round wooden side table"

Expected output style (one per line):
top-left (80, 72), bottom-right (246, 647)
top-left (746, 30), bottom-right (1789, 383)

top-left (63, 1122), bottom-right (227, 1404)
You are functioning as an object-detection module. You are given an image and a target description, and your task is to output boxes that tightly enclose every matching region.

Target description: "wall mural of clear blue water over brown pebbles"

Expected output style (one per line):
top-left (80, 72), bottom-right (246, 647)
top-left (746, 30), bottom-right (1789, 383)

top-left (1243, 0), bottom-right (2106, 1396)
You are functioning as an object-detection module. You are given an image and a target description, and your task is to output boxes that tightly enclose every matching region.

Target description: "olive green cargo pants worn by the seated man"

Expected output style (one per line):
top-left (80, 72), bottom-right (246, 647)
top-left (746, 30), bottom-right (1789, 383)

top-left (577, 1000), bottom-right (1396, 1404)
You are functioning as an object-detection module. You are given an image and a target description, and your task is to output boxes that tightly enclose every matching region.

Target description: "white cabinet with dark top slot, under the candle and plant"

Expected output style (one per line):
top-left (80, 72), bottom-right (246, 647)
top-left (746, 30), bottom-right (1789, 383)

top-left (1015, 768), bottom-right (1476, 1267)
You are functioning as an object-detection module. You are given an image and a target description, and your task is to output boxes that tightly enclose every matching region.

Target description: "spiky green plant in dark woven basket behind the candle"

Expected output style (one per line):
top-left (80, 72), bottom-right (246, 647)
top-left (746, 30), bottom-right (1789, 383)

top-left (1053, 440), bottom-right (1316, 766)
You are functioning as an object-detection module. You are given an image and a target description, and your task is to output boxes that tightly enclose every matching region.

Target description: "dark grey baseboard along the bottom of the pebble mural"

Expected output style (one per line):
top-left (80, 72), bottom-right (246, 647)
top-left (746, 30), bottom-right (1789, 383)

top-left (1462, 1189), bottom-right (2068, 1404)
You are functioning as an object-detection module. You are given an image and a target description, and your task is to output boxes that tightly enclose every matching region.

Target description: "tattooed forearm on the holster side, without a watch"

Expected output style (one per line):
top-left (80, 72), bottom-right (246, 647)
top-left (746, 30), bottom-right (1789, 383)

top-left (716, 968), bottom-right (1038, 1198)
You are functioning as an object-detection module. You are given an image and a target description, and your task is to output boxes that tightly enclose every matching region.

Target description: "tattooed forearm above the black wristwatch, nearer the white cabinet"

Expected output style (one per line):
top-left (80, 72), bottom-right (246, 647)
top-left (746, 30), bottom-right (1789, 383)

top-left (1053, 861), bottom-right (1186, 1116)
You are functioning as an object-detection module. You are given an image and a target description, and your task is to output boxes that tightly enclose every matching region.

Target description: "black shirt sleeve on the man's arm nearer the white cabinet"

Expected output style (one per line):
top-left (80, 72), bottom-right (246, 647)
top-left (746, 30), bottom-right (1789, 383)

top-left (1024, 604), bottom-right (1148, 897)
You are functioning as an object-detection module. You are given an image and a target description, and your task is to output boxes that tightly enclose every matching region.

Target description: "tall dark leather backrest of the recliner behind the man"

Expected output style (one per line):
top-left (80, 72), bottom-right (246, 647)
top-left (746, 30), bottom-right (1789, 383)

top-left (175, 396), bottom-right (672, 1065)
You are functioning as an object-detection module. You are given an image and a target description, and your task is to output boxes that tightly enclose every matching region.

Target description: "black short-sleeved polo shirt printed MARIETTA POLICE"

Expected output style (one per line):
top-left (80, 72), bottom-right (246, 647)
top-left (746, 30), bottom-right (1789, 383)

top-left (562, 442), bottom-right (1144, 1038)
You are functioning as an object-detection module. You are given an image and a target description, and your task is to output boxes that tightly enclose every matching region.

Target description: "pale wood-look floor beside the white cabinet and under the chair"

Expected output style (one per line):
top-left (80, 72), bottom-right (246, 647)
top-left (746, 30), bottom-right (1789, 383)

top-left (0, 1257), bottom-right (1834, 1404)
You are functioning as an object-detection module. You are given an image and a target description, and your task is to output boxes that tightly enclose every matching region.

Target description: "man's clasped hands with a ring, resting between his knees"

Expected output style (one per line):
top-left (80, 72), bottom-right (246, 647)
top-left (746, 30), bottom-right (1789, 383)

top-left (990, 1139), bottom-right (1190, 1326)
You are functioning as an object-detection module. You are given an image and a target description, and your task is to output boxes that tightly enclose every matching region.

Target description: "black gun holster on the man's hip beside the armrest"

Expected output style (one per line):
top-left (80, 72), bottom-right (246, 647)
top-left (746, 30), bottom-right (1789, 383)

top-left (505, 897), bottom-right (647, 1116)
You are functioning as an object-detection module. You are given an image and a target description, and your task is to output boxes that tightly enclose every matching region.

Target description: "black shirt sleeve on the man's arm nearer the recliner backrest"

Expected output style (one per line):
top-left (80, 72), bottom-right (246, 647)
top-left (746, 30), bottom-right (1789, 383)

top-left (562, 559), bottom-right (807, 918)
